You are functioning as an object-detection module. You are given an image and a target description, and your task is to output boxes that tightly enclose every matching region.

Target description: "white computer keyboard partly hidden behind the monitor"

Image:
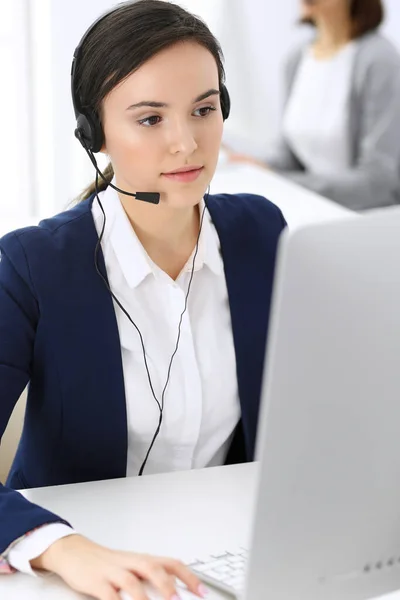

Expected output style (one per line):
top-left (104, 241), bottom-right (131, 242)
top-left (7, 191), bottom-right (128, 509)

top-left (187, 548), bottom-right (248, 597)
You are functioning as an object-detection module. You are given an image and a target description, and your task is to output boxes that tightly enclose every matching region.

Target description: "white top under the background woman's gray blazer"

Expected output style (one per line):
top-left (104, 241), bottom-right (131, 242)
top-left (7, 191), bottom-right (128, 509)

top-left (283, 42), bottom-right (357, 175)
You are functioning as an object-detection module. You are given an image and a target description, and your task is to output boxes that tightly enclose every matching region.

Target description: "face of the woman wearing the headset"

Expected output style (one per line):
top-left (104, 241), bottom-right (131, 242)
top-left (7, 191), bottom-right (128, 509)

top-left (102, 42), bottom-right (223, 207)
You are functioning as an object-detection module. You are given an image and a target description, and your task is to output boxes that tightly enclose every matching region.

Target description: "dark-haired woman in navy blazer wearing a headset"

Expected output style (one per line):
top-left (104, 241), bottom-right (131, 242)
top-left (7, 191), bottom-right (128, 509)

top-left (0, 0), bottom-right (285, 600)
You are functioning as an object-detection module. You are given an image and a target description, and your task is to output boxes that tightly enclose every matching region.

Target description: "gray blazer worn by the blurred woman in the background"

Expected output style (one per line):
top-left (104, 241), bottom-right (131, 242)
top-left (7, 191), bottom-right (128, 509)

top-left (265, 32), bottom-right (400, 210)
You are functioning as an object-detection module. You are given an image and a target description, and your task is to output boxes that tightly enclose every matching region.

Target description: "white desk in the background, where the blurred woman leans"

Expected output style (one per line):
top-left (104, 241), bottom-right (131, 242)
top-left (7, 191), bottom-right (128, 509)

top-left (0, 164), bottom-right (354, 236)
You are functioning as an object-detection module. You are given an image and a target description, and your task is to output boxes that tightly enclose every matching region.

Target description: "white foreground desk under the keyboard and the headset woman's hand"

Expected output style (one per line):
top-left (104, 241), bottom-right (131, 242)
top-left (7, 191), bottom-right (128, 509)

top-left (0, 463), bottom-right (400, 600)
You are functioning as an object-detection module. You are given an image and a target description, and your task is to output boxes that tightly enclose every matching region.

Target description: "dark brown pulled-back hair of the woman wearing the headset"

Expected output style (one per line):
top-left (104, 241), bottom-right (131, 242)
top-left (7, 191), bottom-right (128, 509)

top-left (76, 0), bottom-right (225, 201)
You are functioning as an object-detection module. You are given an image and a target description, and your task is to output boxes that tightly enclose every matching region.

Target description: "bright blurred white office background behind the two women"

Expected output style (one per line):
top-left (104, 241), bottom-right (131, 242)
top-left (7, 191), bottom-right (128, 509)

top-left (0, 0), bottom-right (400, 223)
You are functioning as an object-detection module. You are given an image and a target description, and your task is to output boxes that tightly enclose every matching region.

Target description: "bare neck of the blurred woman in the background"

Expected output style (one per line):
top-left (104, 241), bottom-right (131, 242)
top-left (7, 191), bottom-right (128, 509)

top-left (315, 10), bottom-right (351, 53)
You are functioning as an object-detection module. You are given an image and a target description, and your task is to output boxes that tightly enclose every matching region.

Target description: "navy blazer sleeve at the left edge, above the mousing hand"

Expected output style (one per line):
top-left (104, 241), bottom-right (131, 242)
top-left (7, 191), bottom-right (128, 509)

top-left (0, 232), bottom-right (69, 564)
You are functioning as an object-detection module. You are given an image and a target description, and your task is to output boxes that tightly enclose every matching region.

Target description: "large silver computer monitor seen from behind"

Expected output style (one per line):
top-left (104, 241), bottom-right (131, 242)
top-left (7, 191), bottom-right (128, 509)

top-left (244, 208), bottom-right (400, 600)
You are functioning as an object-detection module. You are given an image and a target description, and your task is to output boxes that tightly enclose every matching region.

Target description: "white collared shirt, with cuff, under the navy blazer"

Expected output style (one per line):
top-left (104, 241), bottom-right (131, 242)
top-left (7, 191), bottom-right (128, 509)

top-left (8, 187), bottom-right (240, 573)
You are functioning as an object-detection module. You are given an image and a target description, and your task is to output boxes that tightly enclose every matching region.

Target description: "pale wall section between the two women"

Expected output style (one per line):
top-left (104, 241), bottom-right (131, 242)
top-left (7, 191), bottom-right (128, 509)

top-left (220, 0), bottom-right (310, 154)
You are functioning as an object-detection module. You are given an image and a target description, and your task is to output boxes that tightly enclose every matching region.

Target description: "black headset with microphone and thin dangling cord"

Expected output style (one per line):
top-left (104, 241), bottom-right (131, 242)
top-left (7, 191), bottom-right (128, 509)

top-left (71, 5), bottom-right (231, 477)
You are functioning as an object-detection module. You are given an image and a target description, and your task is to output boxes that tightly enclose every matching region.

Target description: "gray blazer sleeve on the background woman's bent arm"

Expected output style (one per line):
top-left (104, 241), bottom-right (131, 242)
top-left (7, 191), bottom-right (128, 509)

top-left (285, 41), bottom-right (400, 210)
